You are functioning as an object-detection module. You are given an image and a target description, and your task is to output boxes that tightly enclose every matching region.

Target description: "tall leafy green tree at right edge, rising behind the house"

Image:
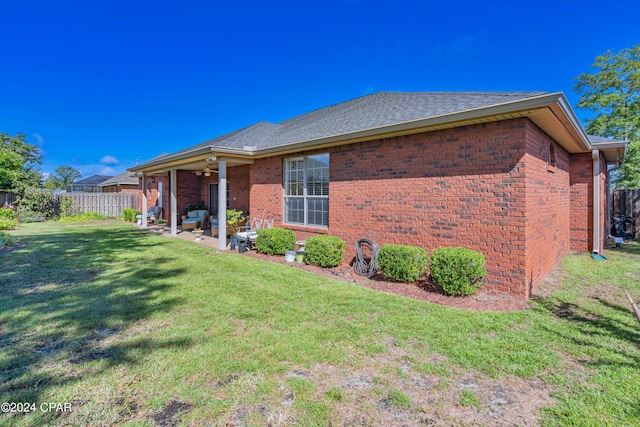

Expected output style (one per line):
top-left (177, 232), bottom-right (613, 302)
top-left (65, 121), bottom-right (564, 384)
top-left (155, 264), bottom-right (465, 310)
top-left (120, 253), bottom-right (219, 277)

top-left (574, 44), bottom-right (640, 188)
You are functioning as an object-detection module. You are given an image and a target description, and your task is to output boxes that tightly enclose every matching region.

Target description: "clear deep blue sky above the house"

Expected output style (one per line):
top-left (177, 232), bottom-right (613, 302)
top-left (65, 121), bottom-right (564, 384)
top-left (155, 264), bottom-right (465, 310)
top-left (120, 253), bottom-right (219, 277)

top-left (0, 0), bottom-right (640, 177)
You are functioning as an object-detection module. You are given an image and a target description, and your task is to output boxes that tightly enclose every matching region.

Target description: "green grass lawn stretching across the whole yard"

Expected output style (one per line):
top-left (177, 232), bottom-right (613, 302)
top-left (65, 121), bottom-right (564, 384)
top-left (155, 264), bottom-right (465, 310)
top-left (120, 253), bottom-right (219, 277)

top-left (0, 221), bottom-right (640, 426)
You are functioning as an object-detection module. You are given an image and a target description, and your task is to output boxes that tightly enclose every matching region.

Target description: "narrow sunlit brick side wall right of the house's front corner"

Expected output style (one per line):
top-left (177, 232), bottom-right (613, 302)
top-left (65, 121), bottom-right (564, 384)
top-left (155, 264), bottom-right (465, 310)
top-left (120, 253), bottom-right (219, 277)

top-left (525, 122), bottom-right (570, 296)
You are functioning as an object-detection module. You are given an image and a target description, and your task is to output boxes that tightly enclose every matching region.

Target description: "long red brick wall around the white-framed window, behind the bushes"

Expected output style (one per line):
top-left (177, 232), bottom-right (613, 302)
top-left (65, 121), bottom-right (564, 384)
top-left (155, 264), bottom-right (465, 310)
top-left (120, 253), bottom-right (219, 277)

top-left (251, 119), bottom-right (528, 295)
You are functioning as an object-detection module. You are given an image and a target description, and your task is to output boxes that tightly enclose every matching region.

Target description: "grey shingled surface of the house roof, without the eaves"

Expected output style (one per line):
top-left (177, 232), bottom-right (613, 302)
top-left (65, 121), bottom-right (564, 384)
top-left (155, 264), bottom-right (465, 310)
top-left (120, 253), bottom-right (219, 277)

top-left (139, 92), bottom-right (546, 163)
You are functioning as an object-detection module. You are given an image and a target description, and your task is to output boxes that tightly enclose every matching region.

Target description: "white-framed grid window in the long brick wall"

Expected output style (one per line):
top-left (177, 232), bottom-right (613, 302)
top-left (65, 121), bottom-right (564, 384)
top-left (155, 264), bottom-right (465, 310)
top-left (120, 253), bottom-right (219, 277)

top-left (284, 154), bottom-right (329, 227)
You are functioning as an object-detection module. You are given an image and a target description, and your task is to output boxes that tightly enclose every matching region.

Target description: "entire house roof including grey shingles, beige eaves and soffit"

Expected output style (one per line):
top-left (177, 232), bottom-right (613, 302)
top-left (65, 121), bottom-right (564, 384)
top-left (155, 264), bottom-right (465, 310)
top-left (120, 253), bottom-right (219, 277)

top-left (130, 92), bottom-right (624, 171)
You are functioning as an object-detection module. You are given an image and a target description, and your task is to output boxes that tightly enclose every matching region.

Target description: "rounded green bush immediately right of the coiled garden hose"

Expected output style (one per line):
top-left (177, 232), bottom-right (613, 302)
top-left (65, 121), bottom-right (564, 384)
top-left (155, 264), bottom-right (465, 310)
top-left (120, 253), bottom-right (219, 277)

top-left (378, 244), bottom-right (427, 282)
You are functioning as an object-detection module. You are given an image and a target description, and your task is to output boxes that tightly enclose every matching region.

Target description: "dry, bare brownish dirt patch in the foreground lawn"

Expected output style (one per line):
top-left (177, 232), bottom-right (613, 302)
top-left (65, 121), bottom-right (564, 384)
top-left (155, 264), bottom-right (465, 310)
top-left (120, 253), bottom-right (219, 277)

top-left (220, 337), bottom-right (554, 427)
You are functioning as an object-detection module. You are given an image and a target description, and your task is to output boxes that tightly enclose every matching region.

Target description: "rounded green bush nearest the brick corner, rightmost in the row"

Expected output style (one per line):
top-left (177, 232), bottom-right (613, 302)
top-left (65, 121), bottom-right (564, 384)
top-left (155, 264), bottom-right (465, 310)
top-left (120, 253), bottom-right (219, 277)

top-left (429, 247), bottom-right (487, 296)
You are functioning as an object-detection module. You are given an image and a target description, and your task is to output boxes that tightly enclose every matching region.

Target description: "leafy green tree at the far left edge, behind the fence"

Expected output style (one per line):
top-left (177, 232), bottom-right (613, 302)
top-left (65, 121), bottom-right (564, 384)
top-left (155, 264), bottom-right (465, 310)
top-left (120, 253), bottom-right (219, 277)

top-left (0, 133), bottom-right (42, 191)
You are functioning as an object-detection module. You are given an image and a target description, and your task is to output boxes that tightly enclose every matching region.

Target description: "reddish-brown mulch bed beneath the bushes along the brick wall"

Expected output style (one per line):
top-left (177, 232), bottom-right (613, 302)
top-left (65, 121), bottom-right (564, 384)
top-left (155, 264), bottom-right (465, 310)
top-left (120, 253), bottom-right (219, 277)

top-left (244, 252), bottom-right (529, 311)
